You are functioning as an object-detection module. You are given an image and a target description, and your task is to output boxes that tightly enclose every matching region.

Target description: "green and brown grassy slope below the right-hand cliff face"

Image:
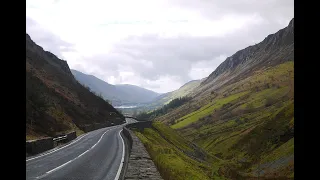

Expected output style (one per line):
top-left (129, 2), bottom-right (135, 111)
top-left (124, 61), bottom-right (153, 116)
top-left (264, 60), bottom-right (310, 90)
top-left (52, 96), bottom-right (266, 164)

top-left (141, 61), bottom-right (294, 179)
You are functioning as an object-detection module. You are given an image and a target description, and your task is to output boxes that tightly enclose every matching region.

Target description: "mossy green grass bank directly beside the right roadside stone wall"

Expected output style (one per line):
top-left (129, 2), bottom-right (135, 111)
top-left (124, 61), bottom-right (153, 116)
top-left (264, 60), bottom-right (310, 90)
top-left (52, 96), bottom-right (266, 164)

top-left (135, 123), bottom-right (211, 180)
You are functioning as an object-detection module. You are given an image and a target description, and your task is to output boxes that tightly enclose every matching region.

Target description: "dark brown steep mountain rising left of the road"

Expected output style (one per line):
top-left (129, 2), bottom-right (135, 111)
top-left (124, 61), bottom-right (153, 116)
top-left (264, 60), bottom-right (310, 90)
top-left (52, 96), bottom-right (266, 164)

top-left (26, 34), bottom-right (124, 139)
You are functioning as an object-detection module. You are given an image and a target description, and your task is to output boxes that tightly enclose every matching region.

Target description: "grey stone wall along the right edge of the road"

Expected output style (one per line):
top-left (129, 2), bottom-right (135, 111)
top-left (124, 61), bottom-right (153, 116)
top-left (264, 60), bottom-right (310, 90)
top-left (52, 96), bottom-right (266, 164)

top-left (123, 122), bottom-right (163, 180)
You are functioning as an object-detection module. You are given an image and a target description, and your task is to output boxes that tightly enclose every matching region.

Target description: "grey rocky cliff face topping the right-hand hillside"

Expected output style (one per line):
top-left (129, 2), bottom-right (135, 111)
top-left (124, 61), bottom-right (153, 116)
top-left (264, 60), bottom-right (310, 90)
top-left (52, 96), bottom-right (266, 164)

top-left (201, 19), bottom-right (294, 88)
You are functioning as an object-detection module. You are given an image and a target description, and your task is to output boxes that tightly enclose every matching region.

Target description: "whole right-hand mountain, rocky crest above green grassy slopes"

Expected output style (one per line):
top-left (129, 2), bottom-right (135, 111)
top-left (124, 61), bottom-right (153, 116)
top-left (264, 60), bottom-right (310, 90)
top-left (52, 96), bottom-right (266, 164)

top-left (140, 19), bottom-right (294, 179)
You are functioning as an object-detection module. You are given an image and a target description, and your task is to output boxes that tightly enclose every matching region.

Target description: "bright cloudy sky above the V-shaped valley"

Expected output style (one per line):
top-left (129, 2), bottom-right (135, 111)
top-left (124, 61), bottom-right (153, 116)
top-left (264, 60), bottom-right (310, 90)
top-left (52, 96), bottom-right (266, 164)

top-left (26, 0), bottom-right (294, 93)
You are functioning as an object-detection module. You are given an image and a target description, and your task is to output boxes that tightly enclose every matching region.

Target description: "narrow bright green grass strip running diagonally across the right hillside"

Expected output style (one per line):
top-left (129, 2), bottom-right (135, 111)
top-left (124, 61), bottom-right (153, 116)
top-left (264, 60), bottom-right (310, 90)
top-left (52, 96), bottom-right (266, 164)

top-left (171, 91), bottom-right (249, 129)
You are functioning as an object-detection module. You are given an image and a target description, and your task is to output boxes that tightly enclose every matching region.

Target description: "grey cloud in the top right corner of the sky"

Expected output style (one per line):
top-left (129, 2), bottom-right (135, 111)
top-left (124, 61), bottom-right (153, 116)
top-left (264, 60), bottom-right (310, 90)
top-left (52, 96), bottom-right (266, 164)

top-left (171, 0), bottom-right (294, 23)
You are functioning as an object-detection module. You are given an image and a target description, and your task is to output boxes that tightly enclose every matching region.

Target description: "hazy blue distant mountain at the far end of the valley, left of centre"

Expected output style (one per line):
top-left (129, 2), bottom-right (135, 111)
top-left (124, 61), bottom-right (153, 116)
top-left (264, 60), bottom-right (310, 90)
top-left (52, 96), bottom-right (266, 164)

top-left (71, 70), bottom-right (159, 105)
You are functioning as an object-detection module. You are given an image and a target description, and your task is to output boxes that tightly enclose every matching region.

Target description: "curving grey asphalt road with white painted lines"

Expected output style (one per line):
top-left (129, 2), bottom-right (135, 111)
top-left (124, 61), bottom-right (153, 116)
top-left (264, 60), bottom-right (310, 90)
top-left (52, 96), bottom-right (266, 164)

top-left (26, 119), bottom-right (135, 180)
